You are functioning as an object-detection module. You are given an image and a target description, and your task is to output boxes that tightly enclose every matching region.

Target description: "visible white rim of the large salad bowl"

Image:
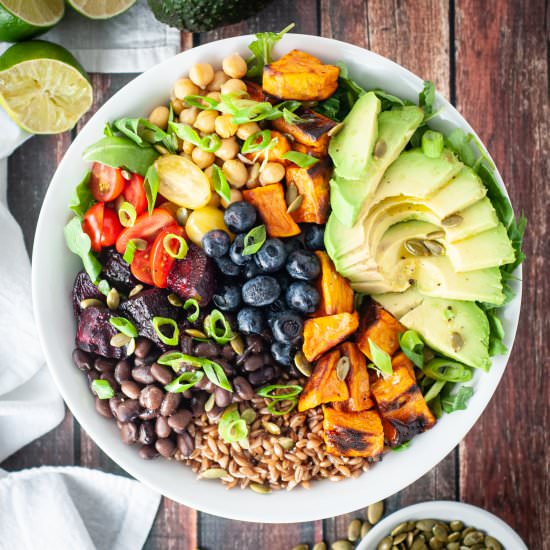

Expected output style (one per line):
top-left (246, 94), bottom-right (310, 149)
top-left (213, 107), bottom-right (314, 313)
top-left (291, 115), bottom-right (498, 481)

top-left (32, 34), bottom-right (521, 523)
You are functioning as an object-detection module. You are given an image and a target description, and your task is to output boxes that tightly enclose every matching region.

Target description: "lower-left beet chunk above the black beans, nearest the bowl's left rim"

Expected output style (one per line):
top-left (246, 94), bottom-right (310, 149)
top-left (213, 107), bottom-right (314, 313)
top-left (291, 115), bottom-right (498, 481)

top-left (76, 306), bottom-right (126, 359)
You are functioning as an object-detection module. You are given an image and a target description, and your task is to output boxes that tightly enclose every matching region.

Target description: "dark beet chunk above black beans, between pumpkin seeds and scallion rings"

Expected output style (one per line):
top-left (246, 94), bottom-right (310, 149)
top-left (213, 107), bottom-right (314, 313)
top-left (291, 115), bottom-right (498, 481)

top-left (119, 288), bottom-right (178, 349)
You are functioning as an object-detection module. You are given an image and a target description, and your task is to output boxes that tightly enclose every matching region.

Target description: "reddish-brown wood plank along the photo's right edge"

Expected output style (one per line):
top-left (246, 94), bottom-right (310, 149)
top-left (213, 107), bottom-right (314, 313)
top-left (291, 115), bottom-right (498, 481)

top-left (456, 0), bottom-right (550, 548)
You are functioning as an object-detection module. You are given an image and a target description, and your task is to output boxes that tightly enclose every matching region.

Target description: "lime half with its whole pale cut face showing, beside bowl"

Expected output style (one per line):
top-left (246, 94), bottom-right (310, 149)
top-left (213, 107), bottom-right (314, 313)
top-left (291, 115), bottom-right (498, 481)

top-left (0, 40), bottom-right (93, 134)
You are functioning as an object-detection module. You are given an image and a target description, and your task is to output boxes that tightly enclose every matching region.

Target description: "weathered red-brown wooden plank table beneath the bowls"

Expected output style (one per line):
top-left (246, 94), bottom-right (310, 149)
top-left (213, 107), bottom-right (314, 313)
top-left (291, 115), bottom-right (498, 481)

top-left (2, 0), bottom-right (550, 550)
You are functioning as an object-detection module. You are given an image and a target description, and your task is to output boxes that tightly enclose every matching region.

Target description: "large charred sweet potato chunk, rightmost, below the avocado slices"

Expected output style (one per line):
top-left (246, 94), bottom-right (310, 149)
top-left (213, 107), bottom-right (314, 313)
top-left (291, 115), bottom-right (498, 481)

top-left (371, 353), bottom-right (435, 446)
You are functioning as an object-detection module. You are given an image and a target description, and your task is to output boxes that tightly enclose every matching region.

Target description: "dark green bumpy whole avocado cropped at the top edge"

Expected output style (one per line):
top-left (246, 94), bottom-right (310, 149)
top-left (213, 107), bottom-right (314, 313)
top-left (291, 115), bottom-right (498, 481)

top-left (147, 0), bottom-right (272, 32)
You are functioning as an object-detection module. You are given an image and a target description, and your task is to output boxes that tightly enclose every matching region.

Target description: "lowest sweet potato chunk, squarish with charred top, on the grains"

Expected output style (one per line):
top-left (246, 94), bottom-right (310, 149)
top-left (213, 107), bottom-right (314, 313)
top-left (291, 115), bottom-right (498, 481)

top-left (323, 407), bottom-right (384, 459)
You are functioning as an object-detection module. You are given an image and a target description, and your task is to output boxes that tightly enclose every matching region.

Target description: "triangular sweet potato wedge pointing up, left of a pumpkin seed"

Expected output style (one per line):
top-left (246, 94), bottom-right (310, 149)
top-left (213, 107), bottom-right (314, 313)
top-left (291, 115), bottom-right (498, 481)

top-left (298, 350), bottom-right (349, 412)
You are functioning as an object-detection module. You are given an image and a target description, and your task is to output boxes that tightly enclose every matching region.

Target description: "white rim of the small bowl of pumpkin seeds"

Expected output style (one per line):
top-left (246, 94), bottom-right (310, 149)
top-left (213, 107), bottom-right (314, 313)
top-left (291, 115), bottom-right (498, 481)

top-left (356, 500), bottom-right (527, 550)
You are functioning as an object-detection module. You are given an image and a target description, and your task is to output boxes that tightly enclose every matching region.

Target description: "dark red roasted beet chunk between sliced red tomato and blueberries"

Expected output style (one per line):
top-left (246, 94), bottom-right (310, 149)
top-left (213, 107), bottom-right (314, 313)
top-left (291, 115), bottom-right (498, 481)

top-left (168, 243), bottom-right (215, 306)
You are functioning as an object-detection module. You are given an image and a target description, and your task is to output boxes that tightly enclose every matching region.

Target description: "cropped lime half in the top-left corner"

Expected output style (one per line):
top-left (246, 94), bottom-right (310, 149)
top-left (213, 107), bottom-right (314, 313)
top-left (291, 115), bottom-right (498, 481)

top-left (0, 0), bottom-right (65, 42)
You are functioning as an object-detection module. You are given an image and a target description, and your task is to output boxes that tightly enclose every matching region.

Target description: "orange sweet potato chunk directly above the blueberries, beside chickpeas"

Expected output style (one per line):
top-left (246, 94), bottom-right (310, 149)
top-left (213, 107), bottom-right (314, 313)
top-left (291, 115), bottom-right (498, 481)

top-left (243, 183), bottom-right (300, 237)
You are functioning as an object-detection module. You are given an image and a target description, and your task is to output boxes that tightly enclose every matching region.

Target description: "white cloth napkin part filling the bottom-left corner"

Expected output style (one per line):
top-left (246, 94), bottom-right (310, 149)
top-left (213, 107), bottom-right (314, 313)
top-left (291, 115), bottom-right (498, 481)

top-left (0, 467), bottom-right (160, 550)
